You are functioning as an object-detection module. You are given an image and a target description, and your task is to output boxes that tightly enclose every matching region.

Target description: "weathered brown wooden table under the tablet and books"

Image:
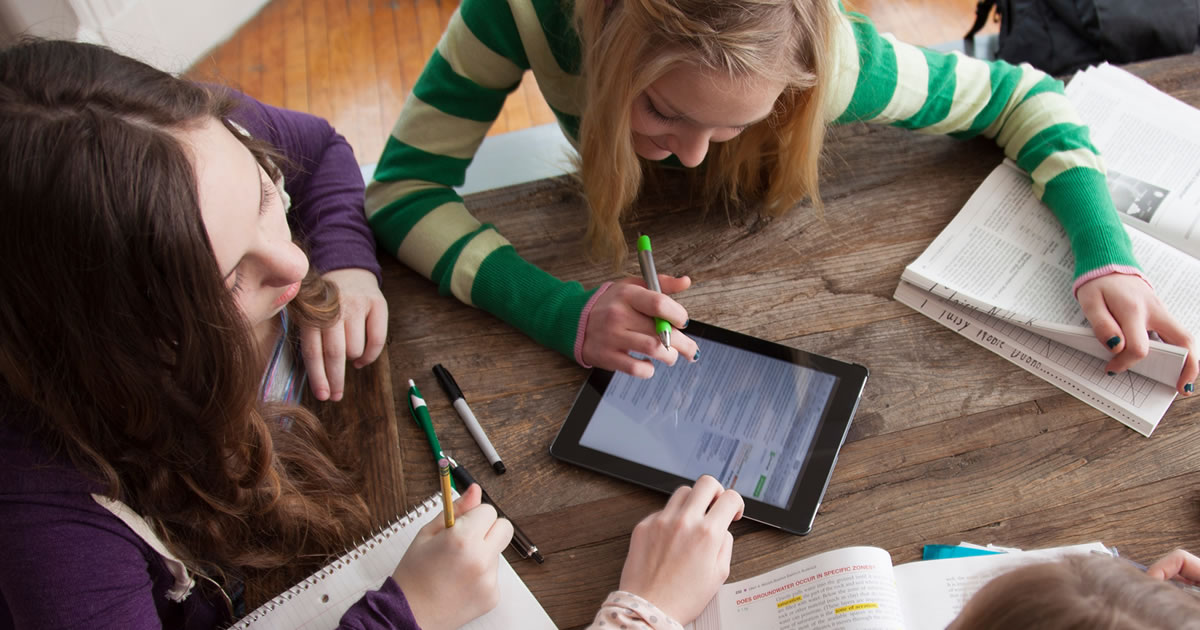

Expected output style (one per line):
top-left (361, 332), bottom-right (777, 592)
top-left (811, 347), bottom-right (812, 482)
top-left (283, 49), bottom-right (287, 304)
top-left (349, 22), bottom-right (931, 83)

top-left (384, 55), bottom-right (1200, 628)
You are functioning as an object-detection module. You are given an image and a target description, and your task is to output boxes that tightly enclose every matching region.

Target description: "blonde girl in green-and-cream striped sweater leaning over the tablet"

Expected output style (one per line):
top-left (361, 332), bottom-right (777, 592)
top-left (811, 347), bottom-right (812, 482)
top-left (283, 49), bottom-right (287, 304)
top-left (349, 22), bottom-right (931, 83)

top-left (367, 0), bottom-right (1200, 395)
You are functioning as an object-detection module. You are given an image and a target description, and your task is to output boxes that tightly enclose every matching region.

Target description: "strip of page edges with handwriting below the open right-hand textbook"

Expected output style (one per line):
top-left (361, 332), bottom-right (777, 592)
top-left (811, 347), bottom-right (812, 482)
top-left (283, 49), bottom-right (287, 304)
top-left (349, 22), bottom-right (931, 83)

top-left (894, 280), bottom-right (1177, 437)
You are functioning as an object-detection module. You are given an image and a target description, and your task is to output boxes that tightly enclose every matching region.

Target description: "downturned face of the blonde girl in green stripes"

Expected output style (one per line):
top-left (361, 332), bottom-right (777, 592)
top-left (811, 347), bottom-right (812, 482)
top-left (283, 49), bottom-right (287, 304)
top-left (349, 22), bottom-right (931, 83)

top-left (630, 66), bottom-right (785, 167)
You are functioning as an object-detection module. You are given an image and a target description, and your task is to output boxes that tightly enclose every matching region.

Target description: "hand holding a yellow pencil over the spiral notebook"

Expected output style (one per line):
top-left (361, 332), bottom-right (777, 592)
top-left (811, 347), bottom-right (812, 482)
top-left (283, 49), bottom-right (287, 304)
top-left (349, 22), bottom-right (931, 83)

top-left (391, 484), bottom-right (512, 630)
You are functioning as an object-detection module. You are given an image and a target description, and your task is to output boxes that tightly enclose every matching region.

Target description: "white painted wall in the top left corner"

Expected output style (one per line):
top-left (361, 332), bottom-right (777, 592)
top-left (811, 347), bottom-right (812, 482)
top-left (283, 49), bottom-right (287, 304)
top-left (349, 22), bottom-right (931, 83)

top-left (0, 0), bottom-right (269, 72)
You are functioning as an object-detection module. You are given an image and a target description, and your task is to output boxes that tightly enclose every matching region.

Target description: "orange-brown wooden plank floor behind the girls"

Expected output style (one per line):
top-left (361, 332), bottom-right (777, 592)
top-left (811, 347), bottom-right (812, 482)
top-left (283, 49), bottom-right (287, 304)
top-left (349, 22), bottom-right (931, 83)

top-left (187, 0), bottom-right (995, 163)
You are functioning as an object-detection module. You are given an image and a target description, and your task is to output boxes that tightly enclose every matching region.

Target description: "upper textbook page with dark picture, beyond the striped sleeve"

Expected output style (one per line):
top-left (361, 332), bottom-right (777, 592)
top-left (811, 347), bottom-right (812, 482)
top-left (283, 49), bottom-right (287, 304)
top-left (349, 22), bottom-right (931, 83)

top-left (1067, 64), bottom-right (1200, 258)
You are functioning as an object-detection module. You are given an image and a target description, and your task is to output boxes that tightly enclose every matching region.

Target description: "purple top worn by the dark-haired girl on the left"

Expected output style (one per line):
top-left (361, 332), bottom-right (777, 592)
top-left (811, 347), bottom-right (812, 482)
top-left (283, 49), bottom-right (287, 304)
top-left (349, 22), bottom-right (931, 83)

top-left (0, 98), bottom-right (418, 630)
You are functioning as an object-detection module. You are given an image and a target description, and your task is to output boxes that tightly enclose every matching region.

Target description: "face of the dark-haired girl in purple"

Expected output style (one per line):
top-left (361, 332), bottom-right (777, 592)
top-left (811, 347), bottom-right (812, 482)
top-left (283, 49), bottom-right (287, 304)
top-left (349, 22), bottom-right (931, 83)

top-left (180, 119), bottom-right (308, 342)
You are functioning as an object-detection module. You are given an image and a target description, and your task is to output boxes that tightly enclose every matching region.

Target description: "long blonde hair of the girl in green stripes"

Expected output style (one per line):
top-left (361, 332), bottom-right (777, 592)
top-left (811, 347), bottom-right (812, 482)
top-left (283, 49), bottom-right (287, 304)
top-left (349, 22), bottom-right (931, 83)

top-left (575, 0), bottom-right (838, 265)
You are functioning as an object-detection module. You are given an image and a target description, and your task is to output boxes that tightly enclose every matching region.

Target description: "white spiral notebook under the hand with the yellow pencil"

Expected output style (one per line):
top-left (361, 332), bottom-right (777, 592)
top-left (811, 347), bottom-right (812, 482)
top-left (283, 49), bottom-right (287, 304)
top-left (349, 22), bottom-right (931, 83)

top-left (233, 496), bottom-right (554, 630)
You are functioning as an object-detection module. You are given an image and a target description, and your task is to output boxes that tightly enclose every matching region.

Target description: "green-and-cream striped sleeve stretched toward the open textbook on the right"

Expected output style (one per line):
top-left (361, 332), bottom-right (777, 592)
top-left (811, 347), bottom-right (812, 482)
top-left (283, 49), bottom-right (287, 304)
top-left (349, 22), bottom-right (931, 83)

top-left (826, 13), bottom-right (1138, 277)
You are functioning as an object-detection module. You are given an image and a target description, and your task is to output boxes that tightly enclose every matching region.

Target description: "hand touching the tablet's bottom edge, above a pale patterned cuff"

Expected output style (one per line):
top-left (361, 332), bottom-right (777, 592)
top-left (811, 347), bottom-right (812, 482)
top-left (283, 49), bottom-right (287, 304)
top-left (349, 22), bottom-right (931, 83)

top-left (619, 475), bottom-right (745, 625)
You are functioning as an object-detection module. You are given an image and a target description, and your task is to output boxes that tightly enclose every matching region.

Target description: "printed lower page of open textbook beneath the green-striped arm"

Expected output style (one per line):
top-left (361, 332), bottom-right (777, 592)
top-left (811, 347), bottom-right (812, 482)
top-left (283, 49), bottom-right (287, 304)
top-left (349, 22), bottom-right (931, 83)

top-left (901, 161), bottom-right (1200, 386)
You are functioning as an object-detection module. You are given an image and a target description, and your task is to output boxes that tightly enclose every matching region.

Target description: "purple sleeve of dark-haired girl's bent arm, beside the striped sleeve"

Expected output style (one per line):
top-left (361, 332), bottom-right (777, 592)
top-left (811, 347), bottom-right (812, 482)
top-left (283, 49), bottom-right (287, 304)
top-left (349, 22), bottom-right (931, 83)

top-left (230, 91), bottom-right (382, 280)
